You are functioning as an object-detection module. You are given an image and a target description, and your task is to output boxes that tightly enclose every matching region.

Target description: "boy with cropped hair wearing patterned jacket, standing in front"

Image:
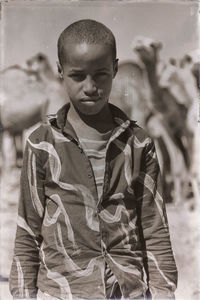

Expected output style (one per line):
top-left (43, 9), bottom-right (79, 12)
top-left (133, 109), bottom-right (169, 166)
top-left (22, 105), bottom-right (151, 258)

top-left (10, 20), bottom-right (177, 300)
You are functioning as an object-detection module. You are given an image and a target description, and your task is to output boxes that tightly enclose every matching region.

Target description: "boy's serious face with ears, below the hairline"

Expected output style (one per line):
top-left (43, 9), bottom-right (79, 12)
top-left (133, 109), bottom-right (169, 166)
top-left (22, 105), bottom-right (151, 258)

top-left (58, 43), bottom-right (117, 115)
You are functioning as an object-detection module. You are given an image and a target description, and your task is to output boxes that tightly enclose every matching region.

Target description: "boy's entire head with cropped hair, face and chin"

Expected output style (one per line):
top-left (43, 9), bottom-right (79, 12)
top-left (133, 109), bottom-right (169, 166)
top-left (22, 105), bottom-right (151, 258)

top-left (58, 20), bottom-right (117, 115)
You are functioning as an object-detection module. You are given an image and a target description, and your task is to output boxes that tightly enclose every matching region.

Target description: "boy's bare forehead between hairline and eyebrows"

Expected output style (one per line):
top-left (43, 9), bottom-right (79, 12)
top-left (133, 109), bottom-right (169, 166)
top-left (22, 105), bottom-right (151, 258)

top-left (63, 43), bottom-right (113, 66)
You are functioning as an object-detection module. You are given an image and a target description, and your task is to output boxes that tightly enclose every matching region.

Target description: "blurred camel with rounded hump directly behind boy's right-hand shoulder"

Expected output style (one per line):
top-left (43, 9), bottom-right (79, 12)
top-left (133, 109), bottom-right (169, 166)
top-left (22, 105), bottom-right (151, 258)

top-left (110, 58), bottom-right (178, 200)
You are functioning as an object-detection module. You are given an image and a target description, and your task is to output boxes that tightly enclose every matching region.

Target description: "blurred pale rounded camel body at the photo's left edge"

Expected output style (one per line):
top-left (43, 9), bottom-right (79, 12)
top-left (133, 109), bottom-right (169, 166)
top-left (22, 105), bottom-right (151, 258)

top-left (0, 65), bottom-right (48, 167)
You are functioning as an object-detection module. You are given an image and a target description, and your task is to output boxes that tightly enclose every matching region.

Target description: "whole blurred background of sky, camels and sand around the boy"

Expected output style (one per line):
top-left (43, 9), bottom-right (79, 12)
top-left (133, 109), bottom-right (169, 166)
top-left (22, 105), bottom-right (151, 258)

top-left (0, 0), bottom-right (200, 300)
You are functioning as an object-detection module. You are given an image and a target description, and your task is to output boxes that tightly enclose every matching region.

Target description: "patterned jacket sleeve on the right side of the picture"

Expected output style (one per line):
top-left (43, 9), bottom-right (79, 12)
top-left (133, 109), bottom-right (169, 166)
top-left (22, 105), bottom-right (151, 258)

top-left (135, 140), bottom-right (177, 299)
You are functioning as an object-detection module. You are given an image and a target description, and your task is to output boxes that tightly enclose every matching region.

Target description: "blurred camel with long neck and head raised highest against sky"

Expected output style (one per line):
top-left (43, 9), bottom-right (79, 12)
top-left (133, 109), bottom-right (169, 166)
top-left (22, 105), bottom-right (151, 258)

top-left (132, 37), bottom-right (199, 203)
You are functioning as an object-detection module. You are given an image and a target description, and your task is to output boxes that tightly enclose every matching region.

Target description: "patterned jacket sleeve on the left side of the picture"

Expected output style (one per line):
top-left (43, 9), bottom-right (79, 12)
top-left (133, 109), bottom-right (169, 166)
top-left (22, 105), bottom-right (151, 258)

top-left (9, 140), bottom-right (45, 299)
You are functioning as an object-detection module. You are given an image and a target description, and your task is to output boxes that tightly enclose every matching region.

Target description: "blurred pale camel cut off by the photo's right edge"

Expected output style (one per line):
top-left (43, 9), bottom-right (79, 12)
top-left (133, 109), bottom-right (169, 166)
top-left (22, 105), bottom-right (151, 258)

top-left (160, 50), bottom-right (200, 204)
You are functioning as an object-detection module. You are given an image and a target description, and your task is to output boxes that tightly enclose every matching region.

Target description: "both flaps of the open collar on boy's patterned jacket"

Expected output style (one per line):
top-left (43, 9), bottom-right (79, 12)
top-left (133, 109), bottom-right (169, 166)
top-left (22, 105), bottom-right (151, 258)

top-left (49, 103), bottom-right (134, 140)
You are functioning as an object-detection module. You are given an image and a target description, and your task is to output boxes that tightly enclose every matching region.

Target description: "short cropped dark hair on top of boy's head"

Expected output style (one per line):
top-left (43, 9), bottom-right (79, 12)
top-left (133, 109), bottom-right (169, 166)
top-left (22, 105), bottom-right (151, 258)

top-left (57, 19), bottom-right (117, 65)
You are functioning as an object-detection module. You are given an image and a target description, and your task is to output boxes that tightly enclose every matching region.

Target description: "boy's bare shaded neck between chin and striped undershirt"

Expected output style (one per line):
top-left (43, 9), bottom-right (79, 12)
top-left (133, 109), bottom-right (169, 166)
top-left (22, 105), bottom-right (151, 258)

top-left (68, 104), bottom-right (114, 133)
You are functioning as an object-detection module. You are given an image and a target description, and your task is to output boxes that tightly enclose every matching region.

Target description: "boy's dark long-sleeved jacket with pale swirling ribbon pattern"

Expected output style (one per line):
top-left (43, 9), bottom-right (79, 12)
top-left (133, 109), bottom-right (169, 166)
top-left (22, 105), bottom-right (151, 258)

top-left (10, 105), bottom-right (177, 300)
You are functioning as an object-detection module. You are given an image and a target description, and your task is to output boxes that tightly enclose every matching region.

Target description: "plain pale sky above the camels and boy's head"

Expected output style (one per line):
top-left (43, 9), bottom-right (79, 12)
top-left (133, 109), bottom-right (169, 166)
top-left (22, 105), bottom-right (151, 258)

top-left (1, 0), bottom-right (200, 69)
